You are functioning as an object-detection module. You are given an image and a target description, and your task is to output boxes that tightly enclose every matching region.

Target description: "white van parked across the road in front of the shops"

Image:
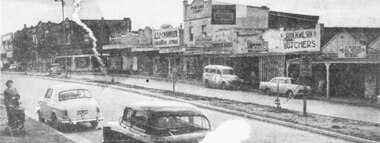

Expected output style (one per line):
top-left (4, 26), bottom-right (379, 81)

top-left (203, 65), bottom-right (239, 89)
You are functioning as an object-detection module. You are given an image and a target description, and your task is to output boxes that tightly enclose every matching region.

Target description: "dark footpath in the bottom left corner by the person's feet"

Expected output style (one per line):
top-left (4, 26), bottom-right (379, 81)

top-left (0, 95), bottom-right (75, 143)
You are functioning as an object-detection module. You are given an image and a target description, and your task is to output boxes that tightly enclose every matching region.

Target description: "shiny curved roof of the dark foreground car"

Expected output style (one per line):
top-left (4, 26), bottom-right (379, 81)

top-left (127, 101), bottom-right (204, 116)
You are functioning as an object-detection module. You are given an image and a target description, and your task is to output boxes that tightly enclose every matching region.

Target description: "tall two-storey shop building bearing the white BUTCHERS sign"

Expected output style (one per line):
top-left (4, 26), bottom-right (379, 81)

top-left (183, 0), bottom-right (320, 81)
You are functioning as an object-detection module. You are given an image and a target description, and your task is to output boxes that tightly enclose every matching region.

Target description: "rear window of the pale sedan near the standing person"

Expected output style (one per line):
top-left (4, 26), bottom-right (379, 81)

top-left (58, 89), bottom-right (91, 101)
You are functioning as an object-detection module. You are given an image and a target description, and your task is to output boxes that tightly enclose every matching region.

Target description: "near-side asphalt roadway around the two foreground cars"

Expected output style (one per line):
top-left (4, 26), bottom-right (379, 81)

top-left (0, 74), bottom-right (347, 143)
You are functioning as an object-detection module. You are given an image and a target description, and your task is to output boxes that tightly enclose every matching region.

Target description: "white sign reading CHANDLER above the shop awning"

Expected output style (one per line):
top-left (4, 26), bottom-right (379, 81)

top-left (153, 28), bottom-right (180, 47)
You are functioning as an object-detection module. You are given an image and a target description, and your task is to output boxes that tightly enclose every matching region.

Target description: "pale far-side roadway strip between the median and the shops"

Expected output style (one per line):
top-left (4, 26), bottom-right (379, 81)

top-left (65, 72), bottom-right (380, 123)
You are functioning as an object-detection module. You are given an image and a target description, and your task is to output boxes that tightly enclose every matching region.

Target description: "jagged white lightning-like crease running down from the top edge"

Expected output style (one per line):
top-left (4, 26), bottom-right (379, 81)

top-left (72, 0), bottom-right (105, 68)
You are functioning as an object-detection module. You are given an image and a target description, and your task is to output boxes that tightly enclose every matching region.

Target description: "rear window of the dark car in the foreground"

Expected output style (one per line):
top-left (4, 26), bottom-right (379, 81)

top-left (153, 116), bottom-right (210, 136)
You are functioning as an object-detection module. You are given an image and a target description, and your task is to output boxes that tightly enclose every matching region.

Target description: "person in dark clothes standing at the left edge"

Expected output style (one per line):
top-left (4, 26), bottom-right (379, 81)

top-left (4, 80), bottom-right (20, 125)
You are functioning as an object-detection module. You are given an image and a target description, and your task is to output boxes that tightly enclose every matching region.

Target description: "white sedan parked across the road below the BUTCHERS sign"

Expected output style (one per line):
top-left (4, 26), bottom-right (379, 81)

top-left (259, 77), bottom-right (311, 97)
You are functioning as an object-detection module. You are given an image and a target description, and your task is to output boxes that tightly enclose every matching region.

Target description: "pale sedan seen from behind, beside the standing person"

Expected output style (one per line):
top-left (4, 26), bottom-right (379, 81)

top-left (36, 83), bottom-right (103, 128)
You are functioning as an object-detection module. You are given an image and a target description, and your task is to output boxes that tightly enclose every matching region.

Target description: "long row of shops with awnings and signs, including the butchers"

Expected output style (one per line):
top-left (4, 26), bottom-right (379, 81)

top-left (95, 0), bottom-right (380, 98)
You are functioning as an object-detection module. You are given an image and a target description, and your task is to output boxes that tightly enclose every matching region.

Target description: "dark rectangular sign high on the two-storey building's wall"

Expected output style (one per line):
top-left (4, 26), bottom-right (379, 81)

top-left (211, 5), bottom-right (236, 24)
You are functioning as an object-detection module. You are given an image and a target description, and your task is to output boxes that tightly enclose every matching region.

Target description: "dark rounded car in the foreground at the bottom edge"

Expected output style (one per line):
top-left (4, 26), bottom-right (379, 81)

top-left (103, 101), bottom-right (211, 143)
